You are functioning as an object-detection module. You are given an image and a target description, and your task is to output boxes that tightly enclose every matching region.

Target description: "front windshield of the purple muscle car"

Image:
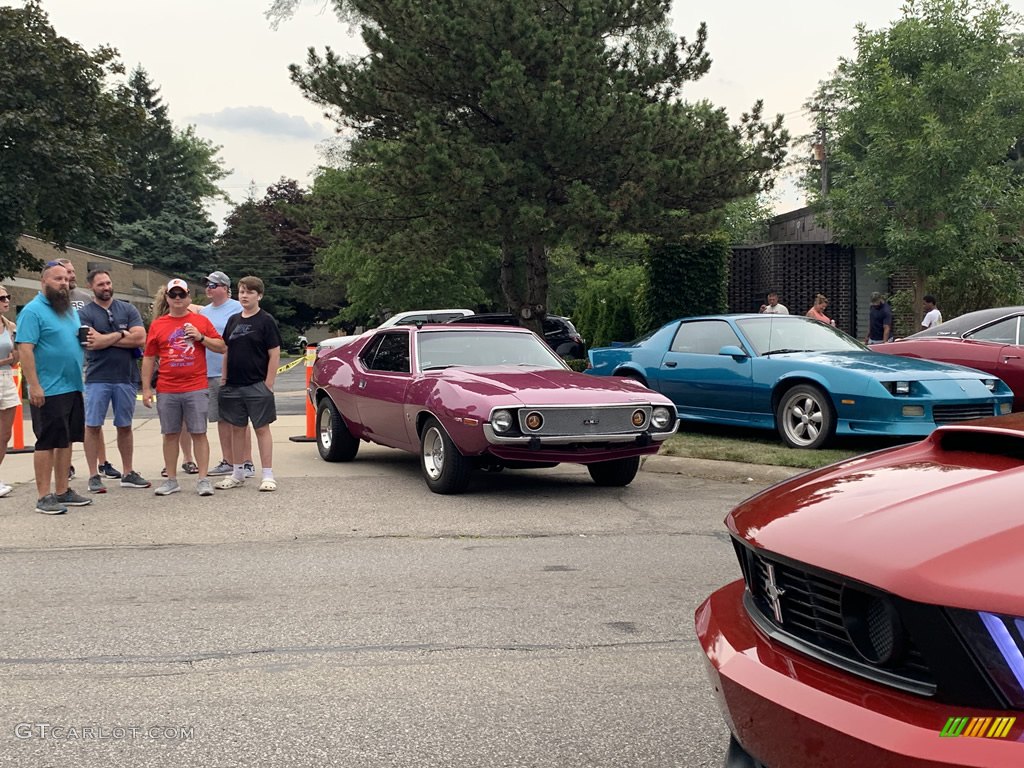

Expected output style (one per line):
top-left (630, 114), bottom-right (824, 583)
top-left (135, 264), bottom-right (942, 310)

top-left (416, 330), bottom-right (565, 371)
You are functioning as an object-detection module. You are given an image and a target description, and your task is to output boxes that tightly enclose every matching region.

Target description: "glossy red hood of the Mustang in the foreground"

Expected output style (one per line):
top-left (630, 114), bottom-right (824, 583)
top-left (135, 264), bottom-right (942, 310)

top-left (726, 417), bottom-right (1024, 615)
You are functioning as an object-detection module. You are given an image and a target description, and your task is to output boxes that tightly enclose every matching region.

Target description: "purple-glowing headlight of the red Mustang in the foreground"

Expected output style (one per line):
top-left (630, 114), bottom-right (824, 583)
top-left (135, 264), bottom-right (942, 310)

top-left (949, 608), bottom-right (1024, 710)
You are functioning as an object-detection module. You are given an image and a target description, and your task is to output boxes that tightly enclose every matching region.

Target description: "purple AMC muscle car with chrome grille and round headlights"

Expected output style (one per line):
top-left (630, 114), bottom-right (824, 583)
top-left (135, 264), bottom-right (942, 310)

top-left (308, 325), bottom-right (677, 494)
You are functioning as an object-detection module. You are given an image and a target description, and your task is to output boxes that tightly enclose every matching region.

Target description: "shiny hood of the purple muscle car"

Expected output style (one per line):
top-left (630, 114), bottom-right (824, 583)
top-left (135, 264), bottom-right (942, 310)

top-left (439, 366), bottom-right (672, 407)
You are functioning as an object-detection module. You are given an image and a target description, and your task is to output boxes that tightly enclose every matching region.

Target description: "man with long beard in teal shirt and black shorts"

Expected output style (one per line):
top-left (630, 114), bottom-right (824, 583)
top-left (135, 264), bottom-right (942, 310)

top-left (17, 261), bottom-right (92, 515)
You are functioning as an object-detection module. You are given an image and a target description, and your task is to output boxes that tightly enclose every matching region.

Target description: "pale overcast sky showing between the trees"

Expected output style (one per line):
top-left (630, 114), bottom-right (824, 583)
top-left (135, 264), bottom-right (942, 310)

top-left (19, 0), bottom-right (1024, 224)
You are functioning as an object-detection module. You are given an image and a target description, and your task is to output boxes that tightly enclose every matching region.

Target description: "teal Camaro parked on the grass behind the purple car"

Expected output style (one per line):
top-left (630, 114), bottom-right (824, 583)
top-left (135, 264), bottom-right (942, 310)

top-left (587, 314), bottom-right (1014, 449)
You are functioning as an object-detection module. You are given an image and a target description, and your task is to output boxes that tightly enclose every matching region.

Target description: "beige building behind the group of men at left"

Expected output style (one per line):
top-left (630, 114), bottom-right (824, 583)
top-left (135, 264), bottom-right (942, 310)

top-left (4, 234), bottom-right (174, 322)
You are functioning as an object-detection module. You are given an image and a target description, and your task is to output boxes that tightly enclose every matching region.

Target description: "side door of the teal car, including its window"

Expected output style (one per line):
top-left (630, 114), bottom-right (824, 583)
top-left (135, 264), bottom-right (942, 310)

top-left (659, 319), bottom-right (751, 421)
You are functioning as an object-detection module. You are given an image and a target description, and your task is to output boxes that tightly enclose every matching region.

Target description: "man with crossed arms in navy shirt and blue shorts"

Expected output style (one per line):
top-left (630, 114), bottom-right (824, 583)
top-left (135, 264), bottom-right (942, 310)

top-left (78, 269), bottom-right (150, 494)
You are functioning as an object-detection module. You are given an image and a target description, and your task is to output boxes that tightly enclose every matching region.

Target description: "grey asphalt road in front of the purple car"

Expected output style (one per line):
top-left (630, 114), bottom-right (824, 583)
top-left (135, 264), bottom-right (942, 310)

top-left (0, 366), bottom-right (760, 768)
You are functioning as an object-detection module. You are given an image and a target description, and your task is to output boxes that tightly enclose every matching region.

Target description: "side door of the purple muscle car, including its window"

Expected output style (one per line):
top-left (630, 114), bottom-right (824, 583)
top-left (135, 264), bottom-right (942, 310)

top-left (355, 328), bottom-right (413, 449)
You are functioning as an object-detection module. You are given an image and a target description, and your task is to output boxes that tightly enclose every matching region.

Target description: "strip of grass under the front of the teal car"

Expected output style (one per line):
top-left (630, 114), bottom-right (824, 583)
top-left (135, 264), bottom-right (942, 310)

top-left (660, 423), bottom-right (891, 469)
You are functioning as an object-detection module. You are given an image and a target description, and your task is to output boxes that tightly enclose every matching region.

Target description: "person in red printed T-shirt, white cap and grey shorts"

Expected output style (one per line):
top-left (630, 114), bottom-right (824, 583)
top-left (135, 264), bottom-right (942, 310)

top-left (142, 278), bottom-right (227, 496)
